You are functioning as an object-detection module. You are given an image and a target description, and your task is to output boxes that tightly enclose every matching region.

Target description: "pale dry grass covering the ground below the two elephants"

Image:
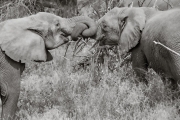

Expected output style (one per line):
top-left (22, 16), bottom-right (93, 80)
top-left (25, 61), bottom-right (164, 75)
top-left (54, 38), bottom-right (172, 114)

top-left (18, 50), bottom-right (180, 120)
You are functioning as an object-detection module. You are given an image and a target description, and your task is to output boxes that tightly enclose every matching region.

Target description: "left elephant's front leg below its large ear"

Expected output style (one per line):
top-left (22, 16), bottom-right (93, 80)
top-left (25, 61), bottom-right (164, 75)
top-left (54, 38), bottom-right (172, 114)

top-left (0, 52), bottom-right (25, 120)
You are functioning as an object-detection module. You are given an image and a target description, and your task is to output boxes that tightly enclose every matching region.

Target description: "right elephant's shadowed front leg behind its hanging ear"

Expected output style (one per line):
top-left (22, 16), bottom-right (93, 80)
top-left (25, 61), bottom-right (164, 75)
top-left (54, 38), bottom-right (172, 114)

top-left (132, 49), bottom-right (148, 85)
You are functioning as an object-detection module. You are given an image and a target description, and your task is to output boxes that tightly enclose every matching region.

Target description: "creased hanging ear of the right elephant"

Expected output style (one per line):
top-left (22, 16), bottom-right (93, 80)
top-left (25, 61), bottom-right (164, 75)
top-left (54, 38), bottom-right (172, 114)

top-left (119, 8), bottom-right (146, 53)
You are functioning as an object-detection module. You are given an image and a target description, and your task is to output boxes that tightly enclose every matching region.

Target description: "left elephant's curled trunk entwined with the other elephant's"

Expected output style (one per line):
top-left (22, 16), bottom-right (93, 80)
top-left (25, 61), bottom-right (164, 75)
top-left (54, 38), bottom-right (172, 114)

top-left (66, 16), bottom-right (97, 40)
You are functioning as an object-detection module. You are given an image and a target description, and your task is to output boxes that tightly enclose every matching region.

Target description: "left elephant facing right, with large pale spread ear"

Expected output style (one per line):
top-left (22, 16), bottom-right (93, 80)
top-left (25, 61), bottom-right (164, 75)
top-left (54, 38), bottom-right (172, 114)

top-left (0, 12), bottom-right (97, 120)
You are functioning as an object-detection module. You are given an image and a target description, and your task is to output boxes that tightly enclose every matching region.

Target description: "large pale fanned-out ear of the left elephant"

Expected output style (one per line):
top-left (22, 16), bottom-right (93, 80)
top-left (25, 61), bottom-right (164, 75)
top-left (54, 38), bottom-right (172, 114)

top-left (0, 17), bottom-right (49, 63)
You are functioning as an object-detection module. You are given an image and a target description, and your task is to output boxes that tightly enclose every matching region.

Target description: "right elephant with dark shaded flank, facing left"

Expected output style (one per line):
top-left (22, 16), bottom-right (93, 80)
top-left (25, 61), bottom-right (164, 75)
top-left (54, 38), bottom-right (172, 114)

top-left (96, 7), bottom-right (180, 90)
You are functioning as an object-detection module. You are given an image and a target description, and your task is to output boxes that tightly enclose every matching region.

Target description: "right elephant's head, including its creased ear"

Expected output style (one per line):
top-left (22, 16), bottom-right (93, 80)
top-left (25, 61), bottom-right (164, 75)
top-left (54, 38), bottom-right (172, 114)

top-left (96, 7), bottom-right (157, 53)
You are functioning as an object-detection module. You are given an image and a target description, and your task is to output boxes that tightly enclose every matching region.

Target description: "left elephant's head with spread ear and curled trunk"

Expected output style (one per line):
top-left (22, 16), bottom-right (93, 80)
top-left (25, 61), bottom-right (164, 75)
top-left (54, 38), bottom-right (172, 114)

top-left (0, 12), bottom-right (96, 62)
